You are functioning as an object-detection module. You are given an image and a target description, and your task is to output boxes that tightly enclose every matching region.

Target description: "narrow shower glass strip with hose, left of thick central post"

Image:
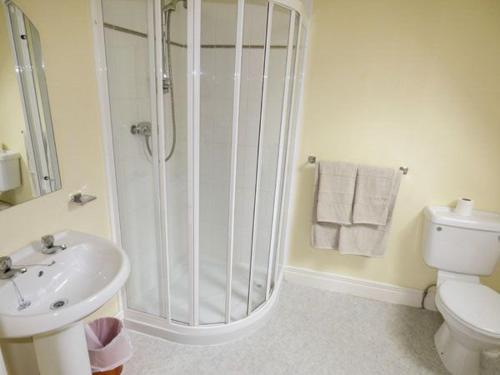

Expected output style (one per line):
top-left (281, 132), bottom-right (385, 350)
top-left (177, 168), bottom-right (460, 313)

top-left (161, 1), bottom-right (193, 324)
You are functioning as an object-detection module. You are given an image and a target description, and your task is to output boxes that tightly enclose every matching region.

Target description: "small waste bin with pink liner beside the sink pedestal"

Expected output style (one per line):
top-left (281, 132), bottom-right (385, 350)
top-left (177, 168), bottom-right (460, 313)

top-left (85, 318), bottom-right (132, 375)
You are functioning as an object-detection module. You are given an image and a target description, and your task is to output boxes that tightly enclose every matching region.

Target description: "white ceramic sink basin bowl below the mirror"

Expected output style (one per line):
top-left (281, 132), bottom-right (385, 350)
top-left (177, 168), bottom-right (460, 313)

top-left (0, 231), bottom-right (130, 339)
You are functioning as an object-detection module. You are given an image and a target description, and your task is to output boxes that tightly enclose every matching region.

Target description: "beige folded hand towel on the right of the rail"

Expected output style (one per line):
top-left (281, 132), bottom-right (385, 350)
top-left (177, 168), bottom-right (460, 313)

top-left (352, 166), bottom-right (400, 225)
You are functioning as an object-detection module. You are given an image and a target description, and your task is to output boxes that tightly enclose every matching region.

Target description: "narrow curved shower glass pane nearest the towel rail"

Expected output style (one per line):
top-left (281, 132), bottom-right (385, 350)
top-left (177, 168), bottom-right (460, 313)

top-left (248, 5), bottom-right (293, 312)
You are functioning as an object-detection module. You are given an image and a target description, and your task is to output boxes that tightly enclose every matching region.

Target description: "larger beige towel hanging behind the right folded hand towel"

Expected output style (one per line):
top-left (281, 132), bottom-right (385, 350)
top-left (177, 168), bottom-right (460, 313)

top-left (338, 171), bottom-right (401, 257)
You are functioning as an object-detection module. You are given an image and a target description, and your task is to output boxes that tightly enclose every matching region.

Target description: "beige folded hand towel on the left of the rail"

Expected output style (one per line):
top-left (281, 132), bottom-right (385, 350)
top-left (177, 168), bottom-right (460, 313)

top-left (315, 161), bottom-right (357, 224)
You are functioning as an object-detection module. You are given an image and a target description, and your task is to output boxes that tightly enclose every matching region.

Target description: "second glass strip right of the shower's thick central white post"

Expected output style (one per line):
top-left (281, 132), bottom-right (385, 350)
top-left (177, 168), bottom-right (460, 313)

top-left (231, 0), bottom-right (268, 320)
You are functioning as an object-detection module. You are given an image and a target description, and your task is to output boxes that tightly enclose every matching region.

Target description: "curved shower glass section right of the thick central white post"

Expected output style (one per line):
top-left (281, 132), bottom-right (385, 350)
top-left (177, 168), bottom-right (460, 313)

top-left (194, 0), bottom-right (299, 324)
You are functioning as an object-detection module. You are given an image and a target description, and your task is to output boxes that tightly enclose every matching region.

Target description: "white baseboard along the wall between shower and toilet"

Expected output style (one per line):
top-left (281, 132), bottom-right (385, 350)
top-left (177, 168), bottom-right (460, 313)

top-left (284, 266), bottom-right (436, 310)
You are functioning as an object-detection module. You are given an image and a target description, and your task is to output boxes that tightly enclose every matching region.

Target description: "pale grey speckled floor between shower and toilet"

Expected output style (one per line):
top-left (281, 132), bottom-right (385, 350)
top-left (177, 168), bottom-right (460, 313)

top-left (124, 282), bottom-right (500, 375)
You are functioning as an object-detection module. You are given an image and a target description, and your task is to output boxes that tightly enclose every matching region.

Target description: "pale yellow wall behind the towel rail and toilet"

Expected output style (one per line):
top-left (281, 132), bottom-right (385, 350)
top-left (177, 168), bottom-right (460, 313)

top-left (289, 0), bottom-right (500, 290)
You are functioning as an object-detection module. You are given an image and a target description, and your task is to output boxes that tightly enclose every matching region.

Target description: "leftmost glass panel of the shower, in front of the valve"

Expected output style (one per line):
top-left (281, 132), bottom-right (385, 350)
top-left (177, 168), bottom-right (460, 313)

top-left (102, 0), bottom-right (160, 315)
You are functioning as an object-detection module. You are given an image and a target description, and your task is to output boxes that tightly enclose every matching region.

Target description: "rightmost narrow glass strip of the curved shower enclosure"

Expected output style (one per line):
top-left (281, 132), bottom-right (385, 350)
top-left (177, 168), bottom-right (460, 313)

top-left (250, 5), bottom-right (291, 310)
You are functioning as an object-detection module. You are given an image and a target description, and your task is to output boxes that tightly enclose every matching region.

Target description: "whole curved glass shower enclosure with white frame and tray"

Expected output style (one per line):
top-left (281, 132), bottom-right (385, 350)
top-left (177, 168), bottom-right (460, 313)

top-left (94, 0), bottom-right (306, 343)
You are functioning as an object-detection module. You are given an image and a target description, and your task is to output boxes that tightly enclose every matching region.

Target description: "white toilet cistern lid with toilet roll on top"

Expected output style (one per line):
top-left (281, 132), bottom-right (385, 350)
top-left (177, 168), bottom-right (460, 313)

top-left (424, 206), bottom-right (500, 232)
